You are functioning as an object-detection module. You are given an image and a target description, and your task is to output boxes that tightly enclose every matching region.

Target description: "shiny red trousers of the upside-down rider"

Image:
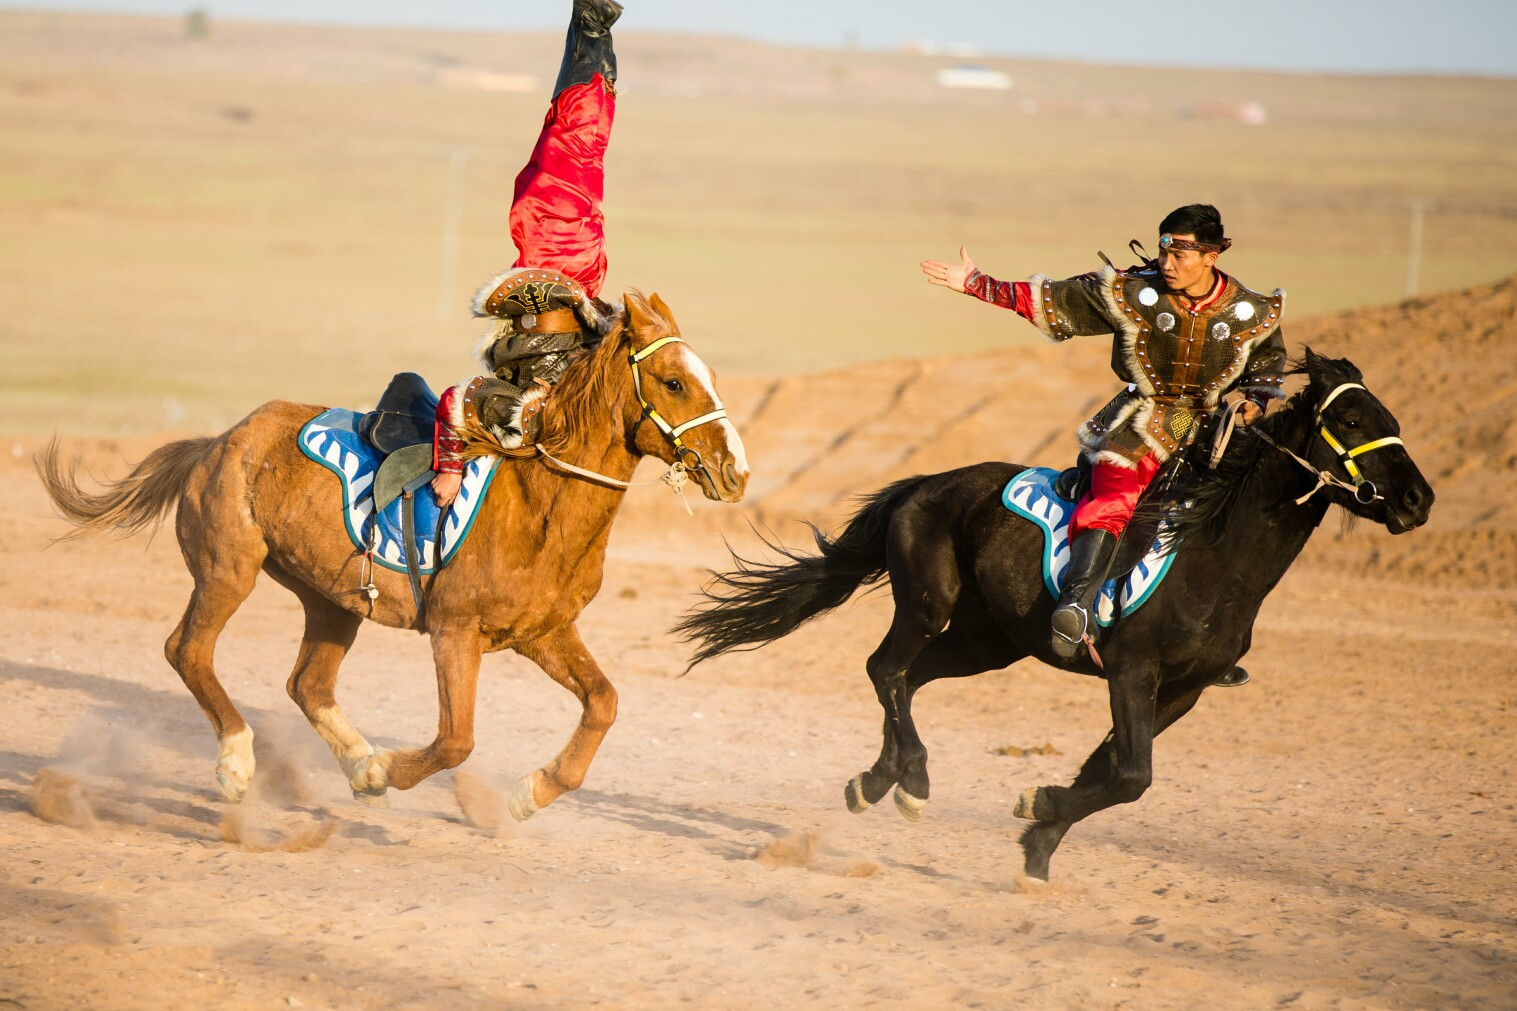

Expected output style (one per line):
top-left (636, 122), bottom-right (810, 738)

top-left (511, 74), bottom-right (616, 296)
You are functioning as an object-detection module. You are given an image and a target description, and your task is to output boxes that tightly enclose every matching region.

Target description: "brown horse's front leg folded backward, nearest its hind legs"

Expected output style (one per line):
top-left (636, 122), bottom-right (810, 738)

top-left (347, 625), bottom-right (484, 803)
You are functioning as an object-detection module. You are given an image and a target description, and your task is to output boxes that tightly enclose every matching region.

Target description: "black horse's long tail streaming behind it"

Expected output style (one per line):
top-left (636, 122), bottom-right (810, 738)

top-left (674, 477), bottom-right (927, 669)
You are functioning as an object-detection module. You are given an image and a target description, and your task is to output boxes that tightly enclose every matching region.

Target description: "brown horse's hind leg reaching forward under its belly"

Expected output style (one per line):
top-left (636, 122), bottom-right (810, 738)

top-left (285, 587), bottom-right (384, 806)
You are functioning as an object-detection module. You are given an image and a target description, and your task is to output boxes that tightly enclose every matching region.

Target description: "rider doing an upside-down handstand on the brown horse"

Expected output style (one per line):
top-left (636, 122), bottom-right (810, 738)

top-left (432, 0), bottom-right (622, 506)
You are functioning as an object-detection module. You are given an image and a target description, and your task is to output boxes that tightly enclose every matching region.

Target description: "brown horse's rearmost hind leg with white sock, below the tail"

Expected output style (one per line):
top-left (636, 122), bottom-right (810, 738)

top-left (164, 522), bottom-right (267, 803)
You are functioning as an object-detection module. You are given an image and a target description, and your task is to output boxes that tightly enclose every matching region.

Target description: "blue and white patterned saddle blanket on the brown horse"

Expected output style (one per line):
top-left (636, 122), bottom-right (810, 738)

top-left (299, 407), bottom-right (501, 574)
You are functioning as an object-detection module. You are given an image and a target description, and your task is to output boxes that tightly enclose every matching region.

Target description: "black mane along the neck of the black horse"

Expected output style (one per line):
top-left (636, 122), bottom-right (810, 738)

top-left (1139, 348), bottom-right (1362, 551)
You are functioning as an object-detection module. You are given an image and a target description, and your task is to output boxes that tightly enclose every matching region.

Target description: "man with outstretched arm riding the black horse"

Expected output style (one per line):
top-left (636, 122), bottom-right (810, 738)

top-left (922, 203), bottom-right (1286, 683)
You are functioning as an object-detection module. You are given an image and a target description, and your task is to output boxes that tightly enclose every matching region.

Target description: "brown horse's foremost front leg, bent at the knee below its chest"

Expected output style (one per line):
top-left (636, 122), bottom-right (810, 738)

top-left (507, 624), bottom-right (616, 821)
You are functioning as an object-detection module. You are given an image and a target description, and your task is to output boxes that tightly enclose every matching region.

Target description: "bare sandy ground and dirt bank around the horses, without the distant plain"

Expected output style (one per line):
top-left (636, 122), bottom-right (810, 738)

top-left (0, 271), bottom-right (1517, 1008)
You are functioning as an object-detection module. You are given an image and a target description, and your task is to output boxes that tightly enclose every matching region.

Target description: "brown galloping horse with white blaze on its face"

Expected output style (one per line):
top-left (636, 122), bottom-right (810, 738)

top-left (38, 291), bottom-right (748, 820)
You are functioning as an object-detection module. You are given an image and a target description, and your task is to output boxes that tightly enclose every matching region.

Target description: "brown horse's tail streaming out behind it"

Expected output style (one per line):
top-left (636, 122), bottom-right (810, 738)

top-left (33, 436), bottom-right (215, 540)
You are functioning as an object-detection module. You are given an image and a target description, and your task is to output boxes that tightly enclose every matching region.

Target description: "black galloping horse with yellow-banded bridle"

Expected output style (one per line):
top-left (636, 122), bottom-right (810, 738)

top-left (675, 349), bottom-right (1434, 880)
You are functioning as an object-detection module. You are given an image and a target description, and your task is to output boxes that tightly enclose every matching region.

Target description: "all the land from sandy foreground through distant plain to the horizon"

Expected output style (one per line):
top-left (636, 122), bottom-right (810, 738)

top-left (0, 12), bottom-right (1517, 1009)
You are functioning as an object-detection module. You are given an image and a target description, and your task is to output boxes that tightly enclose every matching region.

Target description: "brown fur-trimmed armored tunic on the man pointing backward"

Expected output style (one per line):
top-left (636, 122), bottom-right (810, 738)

top-left (1019, 259), bottom-right (1286, 468)
